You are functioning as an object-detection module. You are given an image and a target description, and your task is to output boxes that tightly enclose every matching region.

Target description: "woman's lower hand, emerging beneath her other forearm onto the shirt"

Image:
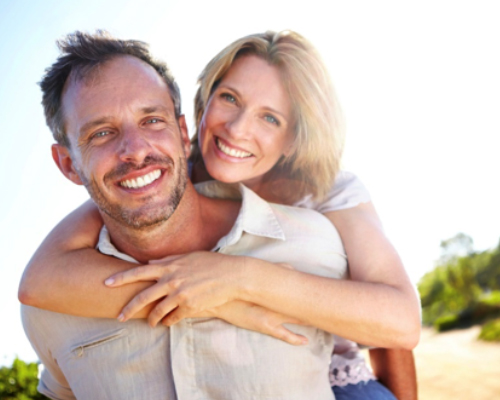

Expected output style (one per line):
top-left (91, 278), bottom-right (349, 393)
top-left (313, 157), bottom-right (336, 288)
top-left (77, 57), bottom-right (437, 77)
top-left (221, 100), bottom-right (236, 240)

top-left (192, 300), bottom-right (308, 346)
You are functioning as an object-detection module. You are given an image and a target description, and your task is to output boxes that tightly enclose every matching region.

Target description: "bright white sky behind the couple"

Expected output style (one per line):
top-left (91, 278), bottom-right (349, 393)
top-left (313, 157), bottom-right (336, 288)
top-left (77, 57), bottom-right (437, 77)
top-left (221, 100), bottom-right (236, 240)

top-left (0, 0), bottom-right (500, 365)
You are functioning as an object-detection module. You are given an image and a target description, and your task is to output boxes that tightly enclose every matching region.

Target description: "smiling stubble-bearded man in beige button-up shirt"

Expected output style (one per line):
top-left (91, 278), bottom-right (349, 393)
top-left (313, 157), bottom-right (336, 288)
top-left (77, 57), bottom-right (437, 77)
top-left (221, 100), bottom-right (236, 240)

top-left (23, 33), bottom-right (346, 400)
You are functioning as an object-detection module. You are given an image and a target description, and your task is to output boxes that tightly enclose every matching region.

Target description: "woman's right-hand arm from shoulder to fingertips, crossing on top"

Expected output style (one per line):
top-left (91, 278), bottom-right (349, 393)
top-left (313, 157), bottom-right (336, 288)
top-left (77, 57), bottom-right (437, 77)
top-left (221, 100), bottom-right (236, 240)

top-left (110, 203), bottom-right (420, 349)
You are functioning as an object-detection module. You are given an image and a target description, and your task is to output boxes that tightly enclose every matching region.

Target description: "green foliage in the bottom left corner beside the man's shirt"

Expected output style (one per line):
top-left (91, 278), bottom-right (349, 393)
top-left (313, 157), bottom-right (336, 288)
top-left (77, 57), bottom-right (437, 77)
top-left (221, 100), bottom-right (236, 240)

top-left (0, 358), bottom-right (47, 400)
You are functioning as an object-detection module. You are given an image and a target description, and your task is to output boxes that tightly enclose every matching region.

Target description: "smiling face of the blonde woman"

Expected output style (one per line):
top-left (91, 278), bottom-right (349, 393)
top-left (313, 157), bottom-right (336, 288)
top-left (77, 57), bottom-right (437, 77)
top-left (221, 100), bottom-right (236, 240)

top-left (199, 55), bottom-right (293, 191)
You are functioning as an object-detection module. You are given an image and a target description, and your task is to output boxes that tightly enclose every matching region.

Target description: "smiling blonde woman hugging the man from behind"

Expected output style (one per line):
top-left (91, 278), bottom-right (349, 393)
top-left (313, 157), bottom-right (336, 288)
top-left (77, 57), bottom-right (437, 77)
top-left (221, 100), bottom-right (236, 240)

top-left (21, 32), bottom-right (419, 398)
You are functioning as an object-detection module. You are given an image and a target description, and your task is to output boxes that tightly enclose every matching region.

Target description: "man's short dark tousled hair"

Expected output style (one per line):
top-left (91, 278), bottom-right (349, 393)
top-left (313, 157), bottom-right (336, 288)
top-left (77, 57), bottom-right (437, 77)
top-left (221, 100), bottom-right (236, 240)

top-left (40, 30), bottom-right (181, 147)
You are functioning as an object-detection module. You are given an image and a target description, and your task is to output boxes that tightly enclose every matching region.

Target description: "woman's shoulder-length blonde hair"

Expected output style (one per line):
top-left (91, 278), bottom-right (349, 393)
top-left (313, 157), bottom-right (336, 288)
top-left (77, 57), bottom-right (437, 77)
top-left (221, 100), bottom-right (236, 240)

top-left (191, 31), bottom-right (344, 203)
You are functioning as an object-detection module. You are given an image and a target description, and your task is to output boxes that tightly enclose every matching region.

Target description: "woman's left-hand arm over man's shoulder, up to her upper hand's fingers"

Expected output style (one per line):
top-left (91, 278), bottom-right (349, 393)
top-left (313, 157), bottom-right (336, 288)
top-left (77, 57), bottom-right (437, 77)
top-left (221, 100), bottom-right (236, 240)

top-left (18, 200), bottom-right (151, 318)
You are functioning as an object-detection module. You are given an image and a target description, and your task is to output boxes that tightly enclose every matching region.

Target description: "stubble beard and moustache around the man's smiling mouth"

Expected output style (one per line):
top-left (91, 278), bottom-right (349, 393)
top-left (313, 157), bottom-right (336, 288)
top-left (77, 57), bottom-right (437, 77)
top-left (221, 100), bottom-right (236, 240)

top-left (78, 156), bottom-right (188, 230)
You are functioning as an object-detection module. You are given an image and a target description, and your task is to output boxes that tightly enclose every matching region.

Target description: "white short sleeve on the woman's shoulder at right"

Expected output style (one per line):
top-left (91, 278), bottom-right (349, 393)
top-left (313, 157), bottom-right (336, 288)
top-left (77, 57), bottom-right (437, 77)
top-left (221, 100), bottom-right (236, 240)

top-left (294, 171), bottom-right (371, 214)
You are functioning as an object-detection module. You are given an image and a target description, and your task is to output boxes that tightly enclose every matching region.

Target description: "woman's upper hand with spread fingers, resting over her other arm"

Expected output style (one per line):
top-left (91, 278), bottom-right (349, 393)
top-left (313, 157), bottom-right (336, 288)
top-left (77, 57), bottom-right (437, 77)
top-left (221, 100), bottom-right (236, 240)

top-left (105, 251), bottom-right (246, 326)
